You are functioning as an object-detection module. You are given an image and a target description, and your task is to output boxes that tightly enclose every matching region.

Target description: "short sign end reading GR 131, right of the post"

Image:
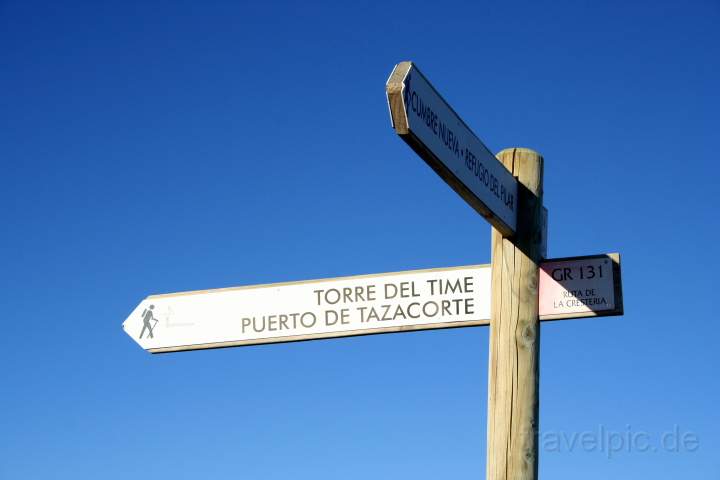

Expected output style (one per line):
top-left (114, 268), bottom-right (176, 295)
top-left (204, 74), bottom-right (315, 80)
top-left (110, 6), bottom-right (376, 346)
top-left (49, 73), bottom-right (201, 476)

top-left (539, 253), bottom-right (623, 320)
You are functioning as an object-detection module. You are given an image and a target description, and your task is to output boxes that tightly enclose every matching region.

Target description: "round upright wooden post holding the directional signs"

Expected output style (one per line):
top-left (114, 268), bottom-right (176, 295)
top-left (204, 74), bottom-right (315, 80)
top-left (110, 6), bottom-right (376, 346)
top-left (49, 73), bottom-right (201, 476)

top-left (487, 148), bottom-right (543, 480)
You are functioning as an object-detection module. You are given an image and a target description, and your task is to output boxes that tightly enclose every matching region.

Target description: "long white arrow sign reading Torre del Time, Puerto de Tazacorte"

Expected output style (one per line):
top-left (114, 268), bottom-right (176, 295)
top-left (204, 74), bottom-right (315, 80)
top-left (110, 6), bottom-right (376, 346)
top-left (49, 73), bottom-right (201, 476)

top-left (123, 265), bottom-right (490, 353)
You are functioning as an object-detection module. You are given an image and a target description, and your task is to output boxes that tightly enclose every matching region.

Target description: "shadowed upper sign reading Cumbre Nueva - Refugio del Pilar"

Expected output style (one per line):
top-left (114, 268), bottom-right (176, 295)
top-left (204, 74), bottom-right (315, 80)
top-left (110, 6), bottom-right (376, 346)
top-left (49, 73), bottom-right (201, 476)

top-left (386, 62), bottom-right (518, 235)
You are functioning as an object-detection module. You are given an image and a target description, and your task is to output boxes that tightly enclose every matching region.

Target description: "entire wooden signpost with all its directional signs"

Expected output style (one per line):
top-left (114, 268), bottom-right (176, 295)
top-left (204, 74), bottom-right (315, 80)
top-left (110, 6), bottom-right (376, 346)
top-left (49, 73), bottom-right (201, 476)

top-left (123, 62), bottom-right (623, 480)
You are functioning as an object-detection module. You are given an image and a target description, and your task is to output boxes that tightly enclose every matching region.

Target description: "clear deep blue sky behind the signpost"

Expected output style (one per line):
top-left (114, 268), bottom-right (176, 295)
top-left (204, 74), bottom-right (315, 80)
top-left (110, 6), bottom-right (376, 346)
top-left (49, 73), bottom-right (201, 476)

top-left (0, 0), bottom-right (720, 480)
